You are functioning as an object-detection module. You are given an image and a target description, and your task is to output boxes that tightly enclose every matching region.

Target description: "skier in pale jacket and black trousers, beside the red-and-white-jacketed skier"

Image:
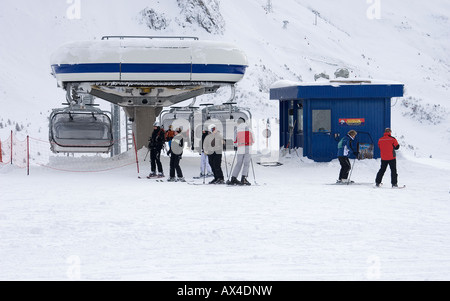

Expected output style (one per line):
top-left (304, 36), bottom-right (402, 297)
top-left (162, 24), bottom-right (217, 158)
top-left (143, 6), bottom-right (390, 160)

top-left (203, 124), bottom-right (225, 184)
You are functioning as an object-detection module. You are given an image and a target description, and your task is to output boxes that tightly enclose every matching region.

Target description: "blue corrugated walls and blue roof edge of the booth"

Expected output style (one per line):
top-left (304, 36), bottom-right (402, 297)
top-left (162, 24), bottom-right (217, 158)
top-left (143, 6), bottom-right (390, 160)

top-left (276, 84), bottom-right (403, 162)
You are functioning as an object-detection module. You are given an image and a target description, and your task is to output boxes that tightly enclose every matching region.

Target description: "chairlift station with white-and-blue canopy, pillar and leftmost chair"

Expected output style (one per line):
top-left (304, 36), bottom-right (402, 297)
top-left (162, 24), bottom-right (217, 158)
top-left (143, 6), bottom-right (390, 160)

top-left (49, 36), bottom-right (248, 154)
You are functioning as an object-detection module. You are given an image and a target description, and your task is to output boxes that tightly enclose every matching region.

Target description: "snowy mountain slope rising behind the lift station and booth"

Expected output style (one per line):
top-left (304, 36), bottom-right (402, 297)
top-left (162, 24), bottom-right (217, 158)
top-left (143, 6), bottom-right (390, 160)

top-left (0, 0), bottom-right (450, 156)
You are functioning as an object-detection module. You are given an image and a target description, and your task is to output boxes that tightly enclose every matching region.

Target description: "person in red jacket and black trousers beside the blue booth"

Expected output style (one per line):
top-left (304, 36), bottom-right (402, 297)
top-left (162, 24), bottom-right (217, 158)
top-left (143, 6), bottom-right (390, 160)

top-left (375, 128), bottom-right (400, 187)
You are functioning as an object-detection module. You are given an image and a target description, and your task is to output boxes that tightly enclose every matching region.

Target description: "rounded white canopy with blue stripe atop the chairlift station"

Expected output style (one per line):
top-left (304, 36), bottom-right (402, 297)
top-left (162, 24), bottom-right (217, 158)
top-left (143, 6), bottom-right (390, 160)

top-left (51, 39), bottom-right (248, 83)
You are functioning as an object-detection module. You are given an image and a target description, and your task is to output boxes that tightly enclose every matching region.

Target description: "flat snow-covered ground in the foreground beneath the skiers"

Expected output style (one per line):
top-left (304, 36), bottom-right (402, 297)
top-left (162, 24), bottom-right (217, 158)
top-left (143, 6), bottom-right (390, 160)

top-left (0, 150), bottom-right (450, 281)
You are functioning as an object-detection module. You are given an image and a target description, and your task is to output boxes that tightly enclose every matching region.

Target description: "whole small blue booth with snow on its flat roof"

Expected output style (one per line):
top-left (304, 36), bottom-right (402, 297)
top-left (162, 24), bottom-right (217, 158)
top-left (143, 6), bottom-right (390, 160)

top-left (270, 79), bottom-right (404, 162)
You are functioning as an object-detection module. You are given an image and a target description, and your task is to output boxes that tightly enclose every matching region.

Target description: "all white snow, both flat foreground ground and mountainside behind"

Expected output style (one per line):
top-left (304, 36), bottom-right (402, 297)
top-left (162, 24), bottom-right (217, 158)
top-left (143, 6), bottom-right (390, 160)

top-left (0, 0), bottom-right (450, 280)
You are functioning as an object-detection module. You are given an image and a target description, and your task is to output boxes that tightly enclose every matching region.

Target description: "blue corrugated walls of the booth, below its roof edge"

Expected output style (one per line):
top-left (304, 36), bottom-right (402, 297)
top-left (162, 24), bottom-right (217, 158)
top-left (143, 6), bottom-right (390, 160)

top-left (280, 98), bottom-right (391, 162)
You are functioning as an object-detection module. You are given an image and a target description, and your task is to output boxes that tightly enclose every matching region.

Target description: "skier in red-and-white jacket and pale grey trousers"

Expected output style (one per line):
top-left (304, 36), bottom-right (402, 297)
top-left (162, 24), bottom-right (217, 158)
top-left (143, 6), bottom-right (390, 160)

top-left (227, 118), bottom-right (254, 185)
